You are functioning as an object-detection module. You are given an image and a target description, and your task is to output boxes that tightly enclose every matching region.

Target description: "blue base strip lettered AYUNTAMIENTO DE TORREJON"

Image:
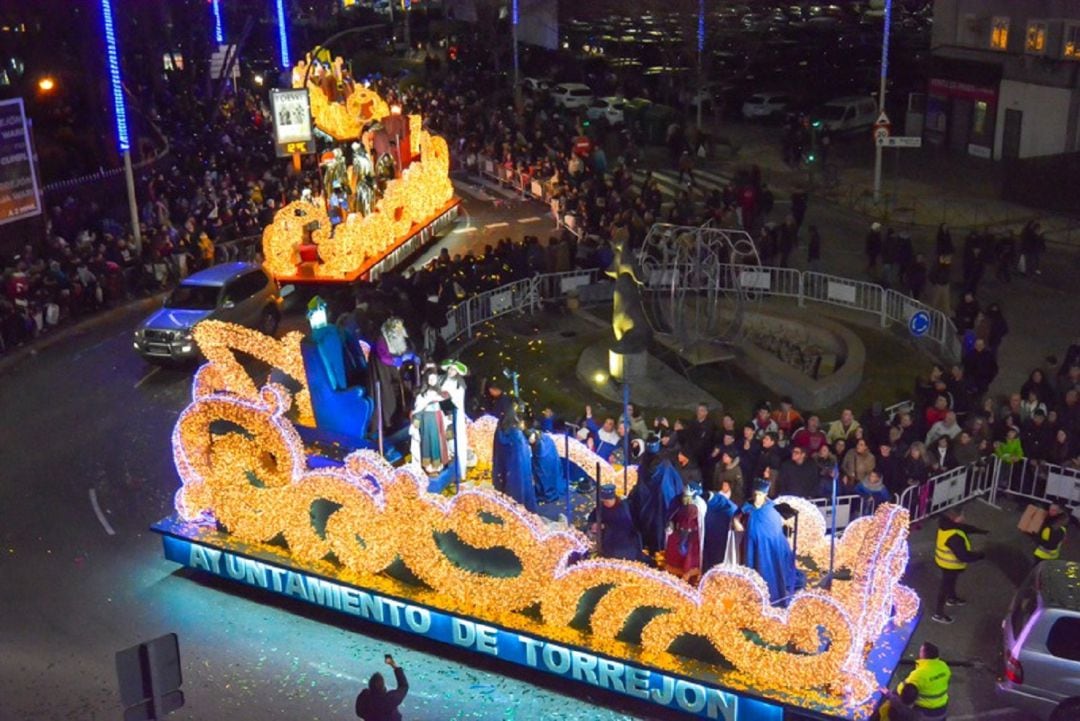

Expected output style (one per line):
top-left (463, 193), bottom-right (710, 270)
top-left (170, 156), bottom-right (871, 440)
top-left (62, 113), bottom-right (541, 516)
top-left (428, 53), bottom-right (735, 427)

top-left (163, 535), bottom-right (783, 721)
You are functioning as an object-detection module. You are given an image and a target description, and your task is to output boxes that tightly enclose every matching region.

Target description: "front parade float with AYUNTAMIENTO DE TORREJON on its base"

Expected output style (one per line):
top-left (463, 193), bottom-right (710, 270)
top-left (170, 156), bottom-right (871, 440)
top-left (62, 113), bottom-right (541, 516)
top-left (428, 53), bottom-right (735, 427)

top-left (154, 313), bottom-right (919, 721)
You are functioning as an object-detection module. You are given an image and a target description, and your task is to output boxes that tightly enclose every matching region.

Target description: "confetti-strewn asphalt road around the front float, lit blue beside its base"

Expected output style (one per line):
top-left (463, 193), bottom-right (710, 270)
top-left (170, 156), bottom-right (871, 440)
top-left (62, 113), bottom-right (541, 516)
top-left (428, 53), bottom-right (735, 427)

top-left (0, 187), bottom-right (1062, 721)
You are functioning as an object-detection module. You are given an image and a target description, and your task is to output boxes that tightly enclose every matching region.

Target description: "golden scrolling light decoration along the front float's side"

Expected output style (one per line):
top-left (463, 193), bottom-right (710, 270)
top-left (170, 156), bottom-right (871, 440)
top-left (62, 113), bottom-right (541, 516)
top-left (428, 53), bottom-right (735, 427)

top-left (173, 371), bottom-right (917, 708)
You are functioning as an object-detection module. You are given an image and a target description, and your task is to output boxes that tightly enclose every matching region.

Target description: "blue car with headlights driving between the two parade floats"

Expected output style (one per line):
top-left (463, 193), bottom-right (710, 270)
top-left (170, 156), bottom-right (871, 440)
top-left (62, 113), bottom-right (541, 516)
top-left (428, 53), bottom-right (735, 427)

top-left (134, 262), bottom-right (281, 361)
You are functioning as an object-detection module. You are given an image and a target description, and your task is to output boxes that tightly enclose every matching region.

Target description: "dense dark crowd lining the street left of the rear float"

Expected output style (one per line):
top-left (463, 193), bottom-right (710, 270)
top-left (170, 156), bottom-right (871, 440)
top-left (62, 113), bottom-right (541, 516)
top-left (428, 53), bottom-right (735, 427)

top-left (0, 89), bottom-right (318, 352)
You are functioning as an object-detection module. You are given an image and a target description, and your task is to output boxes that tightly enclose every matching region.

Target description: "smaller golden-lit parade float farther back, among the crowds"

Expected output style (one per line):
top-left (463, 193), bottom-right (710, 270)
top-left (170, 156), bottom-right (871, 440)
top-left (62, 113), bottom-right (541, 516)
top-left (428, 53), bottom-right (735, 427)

top-left (262, 58), bottom-right (459, 283)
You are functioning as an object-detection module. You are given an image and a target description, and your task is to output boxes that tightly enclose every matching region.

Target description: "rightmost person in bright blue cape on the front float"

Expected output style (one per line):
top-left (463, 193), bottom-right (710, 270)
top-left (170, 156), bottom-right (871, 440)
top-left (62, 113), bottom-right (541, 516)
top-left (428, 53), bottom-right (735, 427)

top-left (742, 479), bottom-right (798, 606)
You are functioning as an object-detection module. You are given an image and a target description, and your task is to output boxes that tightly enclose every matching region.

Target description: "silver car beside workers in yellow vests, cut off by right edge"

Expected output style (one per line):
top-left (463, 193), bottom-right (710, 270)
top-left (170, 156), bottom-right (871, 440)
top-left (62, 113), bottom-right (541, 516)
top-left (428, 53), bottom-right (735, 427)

top-left (997, 561), bottom-right (1080, 721)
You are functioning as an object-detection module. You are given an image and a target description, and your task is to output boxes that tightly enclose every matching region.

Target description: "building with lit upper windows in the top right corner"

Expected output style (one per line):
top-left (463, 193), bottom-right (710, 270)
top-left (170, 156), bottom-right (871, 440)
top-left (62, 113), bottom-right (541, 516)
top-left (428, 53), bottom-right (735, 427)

top-left (923, 0), bottom-right (1080, 160)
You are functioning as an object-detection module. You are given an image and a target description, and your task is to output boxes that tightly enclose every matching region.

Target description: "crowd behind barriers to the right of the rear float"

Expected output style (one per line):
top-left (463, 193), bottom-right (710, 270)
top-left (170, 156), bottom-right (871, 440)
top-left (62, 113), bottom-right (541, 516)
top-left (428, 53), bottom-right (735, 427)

top-left (377, 67), bottom-right (806, 259)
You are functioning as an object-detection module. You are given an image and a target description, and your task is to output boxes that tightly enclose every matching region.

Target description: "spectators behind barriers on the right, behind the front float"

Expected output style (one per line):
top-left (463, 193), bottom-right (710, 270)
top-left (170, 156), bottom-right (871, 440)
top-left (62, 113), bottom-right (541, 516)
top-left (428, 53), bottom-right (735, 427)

top-left (486, 340), bottom-right (1080, 516)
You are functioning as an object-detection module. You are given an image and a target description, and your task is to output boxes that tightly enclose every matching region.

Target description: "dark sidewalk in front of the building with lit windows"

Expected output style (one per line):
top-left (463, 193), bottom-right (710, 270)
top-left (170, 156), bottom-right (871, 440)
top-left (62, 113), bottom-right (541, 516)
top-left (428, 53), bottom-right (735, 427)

top-left (695, 122), bottom-right (1080, 245)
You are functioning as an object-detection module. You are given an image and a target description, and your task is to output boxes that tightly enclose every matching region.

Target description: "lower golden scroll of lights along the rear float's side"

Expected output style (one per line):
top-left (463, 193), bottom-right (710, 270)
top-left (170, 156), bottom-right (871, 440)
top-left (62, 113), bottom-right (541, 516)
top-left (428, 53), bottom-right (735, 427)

top-left (262, 131), bottom-right (454, 280)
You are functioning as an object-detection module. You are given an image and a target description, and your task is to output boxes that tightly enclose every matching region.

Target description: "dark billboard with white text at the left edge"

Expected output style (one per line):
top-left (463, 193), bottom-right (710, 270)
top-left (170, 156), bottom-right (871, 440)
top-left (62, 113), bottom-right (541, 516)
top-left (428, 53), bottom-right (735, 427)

top-left (0, 98), bottom-right (41, 225)
